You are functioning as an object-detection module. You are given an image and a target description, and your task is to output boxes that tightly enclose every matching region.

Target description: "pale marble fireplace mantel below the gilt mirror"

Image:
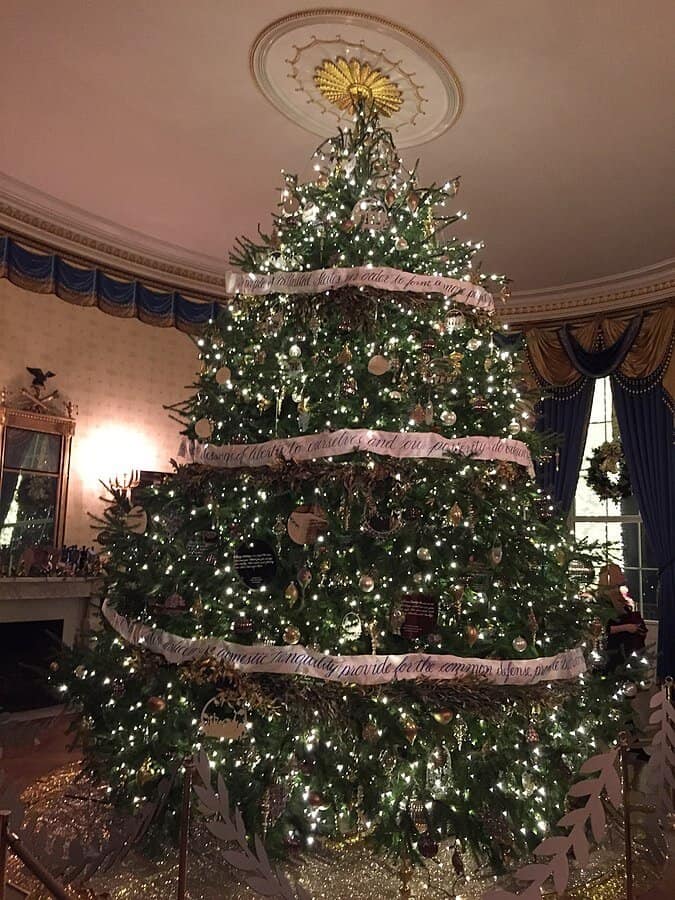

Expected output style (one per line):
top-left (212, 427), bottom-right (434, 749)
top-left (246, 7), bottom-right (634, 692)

top-left (0, 578), bottom-right (101, 646)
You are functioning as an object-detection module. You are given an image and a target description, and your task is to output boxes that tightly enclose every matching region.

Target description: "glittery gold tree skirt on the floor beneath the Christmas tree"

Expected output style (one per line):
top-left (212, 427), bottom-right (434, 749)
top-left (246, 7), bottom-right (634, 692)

top-left (8, 764), bottom-right (654, 900)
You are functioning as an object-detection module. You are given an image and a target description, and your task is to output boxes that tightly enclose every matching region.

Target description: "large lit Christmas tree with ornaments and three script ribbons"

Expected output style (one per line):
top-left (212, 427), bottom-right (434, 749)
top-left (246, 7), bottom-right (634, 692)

top-left (59, 106), bottom-right (644, 867)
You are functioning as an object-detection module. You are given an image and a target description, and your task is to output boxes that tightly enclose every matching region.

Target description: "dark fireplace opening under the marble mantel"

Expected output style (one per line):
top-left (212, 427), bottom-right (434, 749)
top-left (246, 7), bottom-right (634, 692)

top-left (0, 619), bottom-right (63, 712)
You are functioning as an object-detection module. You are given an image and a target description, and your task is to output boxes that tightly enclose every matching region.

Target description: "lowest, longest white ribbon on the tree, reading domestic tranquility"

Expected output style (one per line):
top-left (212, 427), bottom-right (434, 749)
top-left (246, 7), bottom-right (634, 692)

top-left (103, 600), bottom-right (586, 685)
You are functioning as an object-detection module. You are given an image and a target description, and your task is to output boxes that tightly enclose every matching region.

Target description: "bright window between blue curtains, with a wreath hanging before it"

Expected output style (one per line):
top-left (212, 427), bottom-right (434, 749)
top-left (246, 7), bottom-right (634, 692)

top-left (572, 378), bottom-right (658, 619)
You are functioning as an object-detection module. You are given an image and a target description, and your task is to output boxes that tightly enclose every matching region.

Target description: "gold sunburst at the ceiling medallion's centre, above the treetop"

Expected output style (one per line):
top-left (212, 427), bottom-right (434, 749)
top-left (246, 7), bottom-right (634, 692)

top-left (314, 56), bottom-right (403, 116)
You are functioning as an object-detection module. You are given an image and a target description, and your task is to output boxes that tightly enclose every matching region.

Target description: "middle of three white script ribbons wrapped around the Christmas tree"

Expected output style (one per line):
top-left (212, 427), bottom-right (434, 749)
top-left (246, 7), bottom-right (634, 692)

top-left (178, 428), bottom-right (534, 476)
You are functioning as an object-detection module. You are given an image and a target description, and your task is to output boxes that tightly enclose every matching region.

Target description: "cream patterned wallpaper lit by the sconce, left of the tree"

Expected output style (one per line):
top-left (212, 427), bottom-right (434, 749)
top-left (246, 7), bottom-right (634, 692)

top-left (0, 279), bottom-right (198, 545)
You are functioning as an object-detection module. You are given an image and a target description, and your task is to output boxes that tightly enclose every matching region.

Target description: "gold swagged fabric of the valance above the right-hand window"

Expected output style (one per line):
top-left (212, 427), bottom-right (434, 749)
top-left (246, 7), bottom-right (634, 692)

top-left (526, 303), bottom-right (675, 406)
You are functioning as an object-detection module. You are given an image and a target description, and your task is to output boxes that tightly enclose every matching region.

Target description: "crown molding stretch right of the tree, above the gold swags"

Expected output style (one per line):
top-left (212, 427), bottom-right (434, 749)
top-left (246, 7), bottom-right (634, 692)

top-left (502, 259), bottom-right (675, 326)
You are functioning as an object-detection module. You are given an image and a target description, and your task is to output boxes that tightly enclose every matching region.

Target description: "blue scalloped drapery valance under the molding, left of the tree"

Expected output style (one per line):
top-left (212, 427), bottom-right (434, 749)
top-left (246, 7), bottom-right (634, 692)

top-left (0, 235), bottom-right (219, 334)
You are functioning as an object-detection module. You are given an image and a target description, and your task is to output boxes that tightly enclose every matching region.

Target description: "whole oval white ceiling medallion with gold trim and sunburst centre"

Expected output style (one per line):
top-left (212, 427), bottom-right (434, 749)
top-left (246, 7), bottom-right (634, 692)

top-left (250, 9), bottom-right (462, 148)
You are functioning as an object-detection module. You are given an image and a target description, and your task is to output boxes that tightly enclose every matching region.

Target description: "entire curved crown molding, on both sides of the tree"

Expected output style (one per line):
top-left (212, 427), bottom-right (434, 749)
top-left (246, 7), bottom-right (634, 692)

top-left (0, 172), bottom-right (675, 327)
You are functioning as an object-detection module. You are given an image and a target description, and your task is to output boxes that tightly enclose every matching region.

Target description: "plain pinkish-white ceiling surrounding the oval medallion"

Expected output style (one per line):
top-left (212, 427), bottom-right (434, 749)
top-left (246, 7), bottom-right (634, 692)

top-left (0, 0), bottom-right (675, 290)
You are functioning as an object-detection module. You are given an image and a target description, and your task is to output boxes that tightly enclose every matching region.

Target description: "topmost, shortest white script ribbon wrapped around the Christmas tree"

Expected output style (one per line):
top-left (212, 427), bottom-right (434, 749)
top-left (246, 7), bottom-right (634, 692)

top-left (225, 266), bottom-right (495, 312)
